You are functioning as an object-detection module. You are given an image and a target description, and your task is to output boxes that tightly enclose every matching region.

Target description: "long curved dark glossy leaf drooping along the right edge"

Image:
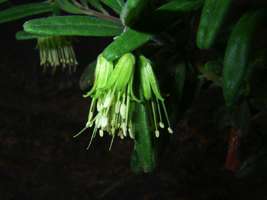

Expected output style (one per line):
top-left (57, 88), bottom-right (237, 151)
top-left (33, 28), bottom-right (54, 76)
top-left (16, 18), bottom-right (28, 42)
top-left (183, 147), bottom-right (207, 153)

top-left (223, 10), bottom-right (266, 107)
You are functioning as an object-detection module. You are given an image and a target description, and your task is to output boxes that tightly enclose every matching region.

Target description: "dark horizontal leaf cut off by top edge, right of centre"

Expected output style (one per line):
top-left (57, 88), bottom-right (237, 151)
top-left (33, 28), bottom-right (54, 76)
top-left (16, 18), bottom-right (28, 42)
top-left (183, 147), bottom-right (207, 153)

top-left (156, 0), bottom-right (203, 12)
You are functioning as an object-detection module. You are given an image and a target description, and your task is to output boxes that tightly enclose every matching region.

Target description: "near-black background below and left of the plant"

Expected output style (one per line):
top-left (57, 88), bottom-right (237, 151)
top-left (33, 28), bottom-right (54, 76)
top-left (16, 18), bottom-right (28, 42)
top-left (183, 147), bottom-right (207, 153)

top-left (0, 1), bottom-right (267, 200)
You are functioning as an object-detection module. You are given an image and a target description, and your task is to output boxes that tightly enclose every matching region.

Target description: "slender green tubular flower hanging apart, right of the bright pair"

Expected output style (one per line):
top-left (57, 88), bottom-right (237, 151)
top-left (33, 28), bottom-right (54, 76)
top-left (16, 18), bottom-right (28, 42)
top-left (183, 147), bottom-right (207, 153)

top-left (139, 55), bottom-right (173, 137)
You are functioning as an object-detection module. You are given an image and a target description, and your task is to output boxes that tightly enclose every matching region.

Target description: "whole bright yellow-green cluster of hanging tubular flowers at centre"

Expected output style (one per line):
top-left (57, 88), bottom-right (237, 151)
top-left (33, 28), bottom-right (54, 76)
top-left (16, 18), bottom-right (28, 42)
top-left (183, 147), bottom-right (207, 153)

top-left (74, 53), bottom-right (173, 148)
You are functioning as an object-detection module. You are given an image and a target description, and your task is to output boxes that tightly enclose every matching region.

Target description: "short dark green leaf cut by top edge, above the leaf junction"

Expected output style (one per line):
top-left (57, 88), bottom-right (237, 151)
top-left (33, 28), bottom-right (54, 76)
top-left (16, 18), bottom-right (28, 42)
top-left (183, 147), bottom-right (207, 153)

top-left (120, 0), bottom-right (150, 26)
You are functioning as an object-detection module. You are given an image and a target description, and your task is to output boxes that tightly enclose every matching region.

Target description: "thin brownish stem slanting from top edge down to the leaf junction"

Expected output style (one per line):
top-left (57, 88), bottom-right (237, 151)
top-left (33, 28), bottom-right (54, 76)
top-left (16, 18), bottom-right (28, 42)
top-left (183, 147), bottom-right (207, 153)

top-left (72, 0), bottom-right (121, 23)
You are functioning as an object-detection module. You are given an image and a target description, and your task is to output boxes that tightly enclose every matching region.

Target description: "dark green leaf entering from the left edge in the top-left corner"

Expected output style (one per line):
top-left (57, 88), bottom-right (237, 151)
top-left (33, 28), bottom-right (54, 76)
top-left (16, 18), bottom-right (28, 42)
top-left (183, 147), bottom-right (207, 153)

top-left (0, 2), bottom-right (53, 23)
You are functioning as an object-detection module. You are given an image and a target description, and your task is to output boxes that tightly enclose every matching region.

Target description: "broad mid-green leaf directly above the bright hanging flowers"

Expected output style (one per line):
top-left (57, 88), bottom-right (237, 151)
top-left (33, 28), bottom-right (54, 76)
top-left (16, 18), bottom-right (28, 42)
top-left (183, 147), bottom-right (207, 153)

top-left (103, 28), bottom-right (151, 61)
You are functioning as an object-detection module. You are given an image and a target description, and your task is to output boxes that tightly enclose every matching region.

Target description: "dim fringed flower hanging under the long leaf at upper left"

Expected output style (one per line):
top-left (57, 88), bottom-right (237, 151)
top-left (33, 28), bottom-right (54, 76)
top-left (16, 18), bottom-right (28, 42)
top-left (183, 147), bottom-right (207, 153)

top-left (37, 36), bottom-right (78, 73)
